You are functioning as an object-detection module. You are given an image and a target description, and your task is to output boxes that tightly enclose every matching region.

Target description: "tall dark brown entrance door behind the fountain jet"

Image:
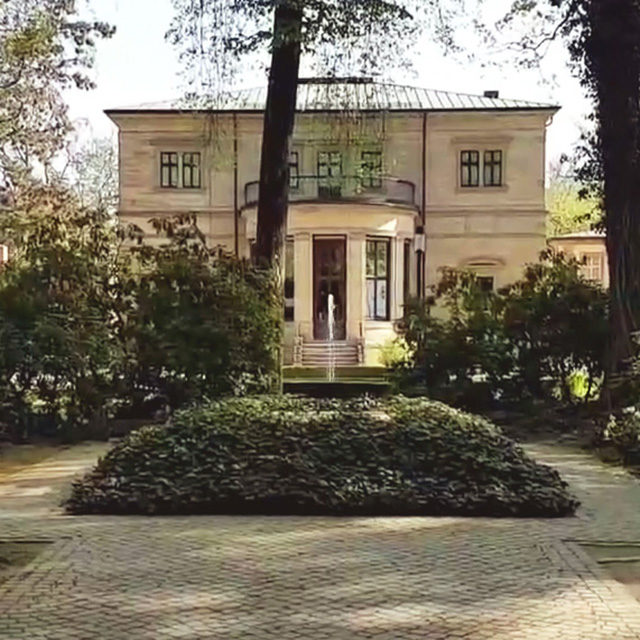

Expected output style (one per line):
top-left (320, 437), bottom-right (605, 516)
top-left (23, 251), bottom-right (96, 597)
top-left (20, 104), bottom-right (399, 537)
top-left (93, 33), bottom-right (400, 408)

top-left (313, 238), bottom-right (347, 340)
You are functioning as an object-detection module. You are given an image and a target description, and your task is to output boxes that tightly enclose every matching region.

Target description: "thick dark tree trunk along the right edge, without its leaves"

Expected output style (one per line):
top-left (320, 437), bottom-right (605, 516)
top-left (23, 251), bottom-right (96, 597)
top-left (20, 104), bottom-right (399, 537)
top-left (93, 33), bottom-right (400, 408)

top-left (585, 0), bottom-right (640, 406)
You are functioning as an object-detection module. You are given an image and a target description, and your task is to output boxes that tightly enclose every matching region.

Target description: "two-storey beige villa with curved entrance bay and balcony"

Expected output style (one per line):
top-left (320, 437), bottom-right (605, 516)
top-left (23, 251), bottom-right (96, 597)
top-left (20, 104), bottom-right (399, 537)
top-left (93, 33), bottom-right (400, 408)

top-left (107, 78), bottom-right (558, 365)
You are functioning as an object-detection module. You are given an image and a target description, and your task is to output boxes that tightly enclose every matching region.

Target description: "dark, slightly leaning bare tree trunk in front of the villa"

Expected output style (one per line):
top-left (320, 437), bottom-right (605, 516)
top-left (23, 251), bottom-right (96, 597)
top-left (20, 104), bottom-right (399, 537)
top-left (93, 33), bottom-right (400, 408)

top-left (255, 3), bottom-right (302, 270)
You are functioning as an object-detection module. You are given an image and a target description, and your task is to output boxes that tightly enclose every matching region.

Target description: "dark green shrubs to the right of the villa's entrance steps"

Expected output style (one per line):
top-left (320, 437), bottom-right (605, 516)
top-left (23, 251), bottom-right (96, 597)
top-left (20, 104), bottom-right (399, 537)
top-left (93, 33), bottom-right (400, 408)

top-left (400, 251), bottom-right (607, 405)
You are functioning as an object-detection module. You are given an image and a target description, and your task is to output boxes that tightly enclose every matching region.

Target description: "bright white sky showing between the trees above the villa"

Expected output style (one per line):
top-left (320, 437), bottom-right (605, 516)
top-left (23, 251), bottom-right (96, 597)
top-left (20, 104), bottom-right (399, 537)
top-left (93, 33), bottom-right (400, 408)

top-left (67, 0), bottom-right (590, 162)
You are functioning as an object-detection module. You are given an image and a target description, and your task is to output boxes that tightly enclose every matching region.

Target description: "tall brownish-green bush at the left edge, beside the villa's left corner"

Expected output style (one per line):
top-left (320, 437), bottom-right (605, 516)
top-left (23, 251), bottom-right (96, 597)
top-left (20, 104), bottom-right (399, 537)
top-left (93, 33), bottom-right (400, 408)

top-left (0, 183), bottom-right (121, 437)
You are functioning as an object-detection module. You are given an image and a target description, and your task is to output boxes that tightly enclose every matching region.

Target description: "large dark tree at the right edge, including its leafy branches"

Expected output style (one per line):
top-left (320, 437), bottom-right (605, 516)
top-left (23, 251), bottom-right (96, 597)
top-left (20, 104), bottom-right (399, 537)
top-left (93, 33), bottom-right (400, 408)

top-left (458, 0), bottom-right (640, 403)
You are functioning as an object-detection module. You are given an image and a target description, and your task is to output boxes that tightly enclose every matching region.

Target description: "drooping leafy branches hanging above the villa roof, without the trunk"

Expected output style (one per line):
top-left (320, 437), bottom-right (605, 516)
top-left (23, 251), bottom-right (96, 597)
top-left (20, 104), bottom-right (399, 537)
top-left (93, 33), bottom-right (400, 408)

top-left (167, 0), bottom-right (472, 97)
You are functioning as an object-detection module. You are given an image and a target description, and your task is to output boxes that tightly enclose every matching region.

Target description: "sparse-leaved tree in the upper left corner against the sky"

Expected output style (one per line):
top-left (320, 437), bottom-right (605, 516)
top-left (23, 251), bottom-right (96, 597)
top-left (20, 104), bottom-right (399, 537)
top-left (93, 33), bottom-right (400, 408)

top-left (0, 0), bottom-right (114, 189)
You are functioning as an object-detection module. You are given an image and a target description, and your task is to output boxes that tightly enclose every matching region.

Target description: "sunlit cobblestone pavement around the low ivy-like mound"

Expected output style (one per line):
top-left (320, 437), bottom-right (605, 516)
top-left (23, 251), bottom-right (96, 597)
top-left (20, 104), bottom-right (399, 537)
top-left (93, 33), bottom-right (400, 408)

top-left (0, 445), bottom-right (640, 640)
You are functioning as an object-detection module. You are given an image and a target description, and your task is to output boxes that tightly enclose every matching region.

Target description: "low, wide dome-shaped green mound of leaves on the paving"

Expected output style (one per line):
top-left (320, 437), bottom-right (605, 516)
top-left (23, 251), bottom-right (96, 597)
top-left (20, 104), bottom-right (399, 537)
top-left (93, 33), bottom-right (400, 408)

top-left (66, 396), bottom-right (578, 516)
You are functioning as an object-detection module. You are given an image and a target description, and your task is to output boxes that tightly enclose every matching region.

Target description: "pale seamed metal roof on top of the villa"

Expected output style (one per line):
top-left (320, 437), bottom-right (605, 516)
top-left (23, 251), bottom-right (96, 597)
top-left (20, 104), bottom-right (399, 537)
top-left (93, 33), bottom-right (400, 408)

top-left (107, 78), bottom-right (559, 114)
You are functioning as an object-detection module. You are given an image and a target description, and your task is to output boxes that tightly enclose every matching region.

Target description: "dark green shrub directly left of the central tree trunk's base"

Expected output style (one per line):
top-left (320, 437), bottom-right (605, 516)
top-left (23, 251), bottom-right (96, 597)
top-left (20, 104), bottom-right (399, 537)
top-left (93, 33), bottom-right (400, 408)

top-left (118, 216), bottom-right (282, 407)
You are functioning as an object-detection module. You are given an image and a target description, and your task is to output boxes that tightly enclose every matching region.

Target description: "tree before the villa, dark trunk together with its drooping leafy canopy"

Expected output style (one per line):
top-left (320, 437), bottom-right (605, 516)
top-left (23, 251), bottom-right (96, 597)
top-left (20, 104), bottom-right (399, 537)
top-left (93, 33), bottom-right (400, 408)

top-left (167, 0), bottom-right (462, 268)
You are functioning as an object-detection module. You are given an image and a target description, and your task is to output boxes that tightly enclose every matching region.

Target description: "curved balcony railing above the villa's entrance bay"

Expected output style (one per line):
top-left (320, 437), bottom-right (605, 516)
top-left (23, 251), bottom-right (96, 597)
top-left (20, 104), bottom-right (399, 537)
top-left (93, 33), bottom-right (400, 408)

top-left (244, 176), bottom-right (416, 207)
